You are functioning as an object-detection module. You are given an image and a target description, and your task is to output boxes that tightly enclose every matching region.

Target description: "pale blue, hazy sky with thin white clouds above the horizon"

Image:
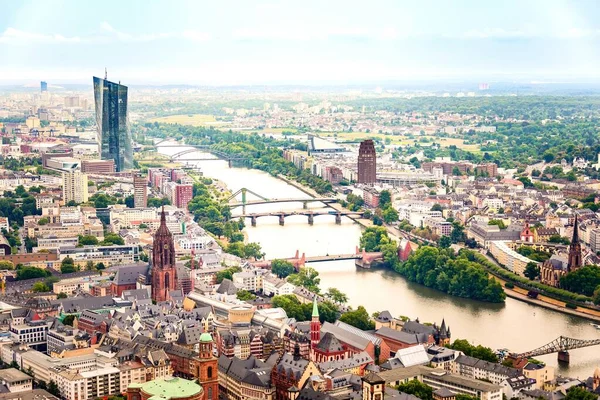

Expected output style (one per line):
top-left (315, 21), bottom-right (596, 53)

top-left (0, 0), bottom-right (600, 85)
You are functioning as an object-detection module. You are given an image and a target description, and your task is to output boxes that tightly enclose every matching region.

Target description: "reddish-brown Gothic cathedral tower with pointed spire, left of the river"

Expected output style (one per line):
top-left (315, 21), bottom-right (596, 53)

top-left (152, 207), bottom-right (177, 303)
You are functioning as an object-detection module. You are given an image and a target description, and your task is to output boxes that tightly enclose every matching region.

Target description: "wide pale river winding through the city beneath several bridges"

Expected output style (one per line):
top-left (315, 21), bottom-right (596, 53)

top-left (160, 148), bottom-right (600, 379)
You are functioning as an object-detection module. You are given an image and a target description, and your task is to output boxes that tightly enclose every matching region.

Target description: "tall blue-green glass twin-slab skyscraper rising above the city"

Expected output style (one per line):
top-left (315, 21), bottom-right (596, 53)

top-left (94, 77), bottom-right (133, 172)
